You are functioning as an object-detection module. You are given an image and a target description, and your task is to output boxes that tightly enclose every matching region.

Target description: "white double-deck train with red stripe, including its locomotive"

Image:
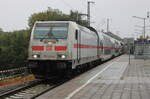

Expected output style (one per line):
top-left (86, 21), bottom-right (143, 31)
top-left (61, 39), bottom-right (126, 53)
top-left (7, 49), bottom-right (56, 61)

top-left (28, 21), bottom-right (123, 78)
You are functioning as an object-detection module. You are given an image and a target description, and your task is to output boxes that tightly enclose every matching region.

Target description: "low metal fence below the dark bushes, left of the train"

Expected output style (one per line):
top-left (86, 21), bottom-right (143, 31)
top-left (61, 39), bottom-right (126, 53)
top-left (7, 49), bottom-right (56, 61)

top-left (0, 67), bottom-right (28, 81)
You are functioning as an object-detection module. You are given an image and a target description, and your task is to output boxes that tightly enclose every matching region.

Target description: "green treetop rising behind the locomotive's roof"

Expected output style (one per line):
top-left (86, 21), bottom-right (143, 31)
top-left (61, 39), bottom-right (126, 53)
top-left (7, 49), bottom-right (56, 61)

top-left (28, 8), bottom-right (87, 28)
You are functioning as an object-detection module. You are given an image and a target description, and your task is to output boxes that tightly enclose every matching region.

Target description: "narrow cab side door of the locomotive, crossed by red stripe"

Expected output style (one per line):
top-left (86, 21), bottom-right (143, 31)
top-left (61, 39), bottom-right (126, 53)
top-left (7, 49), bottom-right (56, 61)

top-left (75, 30), bottom-right (81, 62)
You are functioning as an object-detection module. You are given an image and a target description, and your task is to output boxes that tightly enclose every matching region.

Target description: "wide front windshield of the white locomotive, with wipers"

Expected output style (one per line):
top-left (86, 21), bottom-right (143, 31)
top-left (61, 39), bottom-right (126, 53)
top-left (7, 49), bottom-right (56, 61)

top-left (34, 23), bottom-right (68, 39)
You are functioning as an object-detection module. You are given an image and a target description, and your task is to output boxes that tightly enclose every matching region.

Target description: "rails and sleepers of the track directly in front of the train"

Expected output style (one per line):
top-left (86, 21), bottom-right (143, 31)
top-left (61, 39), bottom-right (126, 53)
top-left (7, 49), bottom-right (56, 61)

top-left (0, 76), bottom-right (66, 99)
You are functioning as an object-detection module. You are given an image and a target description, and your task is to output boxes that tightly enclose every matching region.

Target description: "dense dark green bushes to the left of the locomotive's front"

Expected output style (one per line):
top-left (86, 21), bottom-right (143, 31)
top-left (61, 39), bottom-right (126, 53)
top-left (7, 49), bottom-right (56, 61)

top-left (0, 30), bottom-right (30, 68)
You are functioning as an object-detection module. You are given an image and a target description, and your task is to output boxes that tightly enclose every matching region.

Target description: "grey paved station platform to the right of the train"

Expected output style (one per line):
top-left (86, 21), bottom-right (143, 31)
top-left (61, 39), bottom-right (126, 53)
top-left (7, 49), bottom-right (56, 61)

top-left (37, 55), bottom-right (150, 99)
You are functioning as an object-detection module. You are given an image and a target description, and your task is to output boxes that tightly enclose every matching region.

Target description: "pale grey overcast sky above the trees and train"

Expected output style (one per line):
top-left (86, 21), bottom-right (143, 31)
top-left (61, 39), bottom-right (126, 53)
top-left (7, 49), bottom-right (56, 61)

top-left (0, 0), bottom-right (150, 37)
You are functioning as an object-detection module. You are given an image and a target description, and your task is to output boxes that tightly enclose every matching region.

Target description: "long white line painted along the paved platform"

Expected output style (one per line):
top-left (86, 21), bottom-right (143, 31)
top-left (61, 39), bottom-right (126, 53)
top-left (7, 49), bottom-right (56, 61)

top-left (65, 58), bottom-right (120, 99)
